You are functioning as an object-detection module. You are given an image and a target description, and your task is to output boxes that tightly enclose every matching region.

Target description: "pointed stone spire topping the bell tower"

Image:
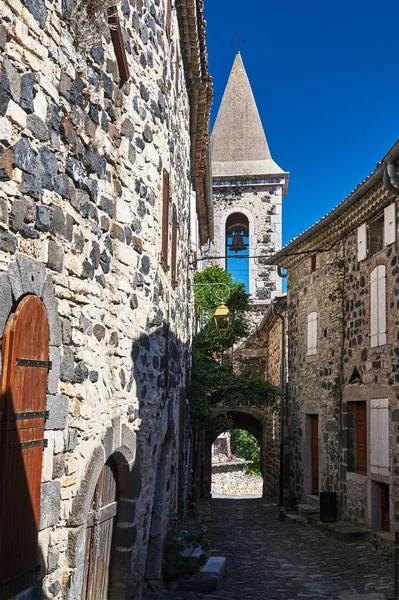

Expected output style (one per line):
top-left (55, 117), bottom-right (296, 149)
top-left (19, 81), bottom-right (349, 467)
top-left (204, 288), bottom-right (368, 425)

top-left (211, 52), bottom-right (284, 177)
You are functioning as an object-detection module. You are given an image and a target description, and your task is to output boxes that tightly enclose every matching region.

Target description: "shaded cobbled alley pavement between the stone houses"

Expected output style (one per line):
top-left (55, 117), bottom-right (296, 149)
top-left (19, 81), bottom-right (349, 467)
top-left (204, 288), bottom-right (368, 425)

top-left (145, 498), bottom-right (393, 600)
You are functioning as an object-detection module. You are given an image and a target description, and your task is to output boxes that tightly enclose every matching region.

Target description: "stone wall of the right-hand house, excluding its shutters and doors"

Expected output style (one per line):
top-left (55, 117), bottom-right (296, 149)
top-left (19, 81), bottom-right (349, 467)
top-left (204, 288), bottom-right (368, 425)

top-left (281, 157), bottom-right (399, 530)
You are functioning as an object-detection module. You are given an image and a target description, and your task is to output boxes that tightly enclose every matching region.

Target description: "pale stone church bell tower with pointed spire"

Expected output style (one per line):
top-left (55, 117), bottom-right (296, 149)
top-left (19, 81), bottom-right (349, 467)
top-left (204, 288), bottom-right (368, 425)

top-left (208, 52), bottom-right (288, 322)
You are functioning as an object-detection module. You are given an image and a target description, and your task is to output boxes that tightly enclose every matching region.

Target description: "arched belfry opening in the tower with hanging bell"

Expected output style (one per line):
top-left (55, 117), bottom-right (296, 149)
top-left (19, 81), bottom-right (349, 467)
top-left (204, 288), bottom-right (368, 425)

top-left (226, 213), bottom-right (249, 293)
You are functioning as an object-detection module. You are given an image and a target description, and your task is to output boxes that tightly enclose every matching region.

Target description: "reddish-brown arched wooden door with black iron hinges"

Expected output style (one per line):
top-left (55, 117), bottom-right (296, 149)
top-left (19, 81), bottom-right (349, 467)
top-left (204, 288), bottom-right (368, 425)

top-left (0, 296), bottom-right (50, 598)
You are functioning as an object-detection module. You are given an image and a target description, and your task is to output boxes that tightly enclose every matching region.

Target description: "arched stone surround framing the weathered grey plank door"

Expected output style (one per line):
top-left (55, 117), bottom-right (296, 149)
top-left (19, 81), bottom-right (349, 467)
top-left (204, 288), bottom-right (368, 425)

top-left (67, 422), bottom-right (141, 600)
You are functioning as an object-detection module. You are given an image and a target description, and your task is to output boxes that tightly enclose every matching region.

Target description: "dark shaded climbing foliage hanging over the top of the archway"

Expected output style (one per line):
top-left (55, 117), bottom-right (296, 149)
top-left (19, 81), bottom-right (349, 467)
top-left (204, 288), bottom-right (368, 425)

top-left (190, 350), bottom-right (278, 433)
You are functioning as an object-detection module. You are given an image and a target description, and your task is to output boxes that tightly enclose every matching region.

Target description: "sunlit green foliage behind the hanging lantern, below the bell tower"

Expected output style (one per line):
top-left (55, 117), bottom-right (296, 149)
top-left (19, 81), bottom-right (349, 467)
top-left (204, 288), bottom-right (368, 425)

top-left (194, 265), bottom-right (249, 353)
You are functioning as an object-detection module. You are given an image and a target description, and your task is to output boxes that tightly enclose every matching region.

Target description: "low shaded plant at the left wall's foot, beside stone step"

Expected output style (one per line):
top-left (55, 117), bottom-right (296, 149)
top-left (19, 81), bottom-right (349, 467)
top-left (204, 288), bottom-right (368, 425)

top-left (162, 520), bottom-right (211, 581)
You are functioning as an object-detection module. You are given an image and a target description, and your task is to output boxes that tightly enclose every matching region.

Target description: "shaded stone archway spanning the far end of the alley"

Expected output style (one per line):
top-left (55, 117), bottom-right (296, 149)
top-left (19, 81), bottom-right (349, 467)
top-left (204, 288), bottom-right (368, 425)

top-left (202, 406), bottom-right (279, 501)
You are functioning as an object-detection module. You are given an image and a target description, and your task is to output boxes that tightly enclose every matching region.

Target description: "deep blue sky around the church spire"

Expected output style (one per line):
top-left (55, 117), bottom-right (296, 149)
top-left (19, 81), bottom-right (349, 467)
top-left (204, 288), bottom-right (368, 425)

top-left (205, 0), bottom-right (399, 243)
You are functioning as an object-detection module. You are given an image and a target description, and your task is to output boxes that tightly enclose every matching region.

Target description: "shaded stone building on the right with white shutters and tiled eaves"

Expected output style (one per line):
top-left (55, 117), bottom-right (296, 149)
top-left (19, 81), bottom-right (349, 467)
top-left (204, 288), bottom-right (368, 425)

top-left (270, 142), bottom-right (399, 531)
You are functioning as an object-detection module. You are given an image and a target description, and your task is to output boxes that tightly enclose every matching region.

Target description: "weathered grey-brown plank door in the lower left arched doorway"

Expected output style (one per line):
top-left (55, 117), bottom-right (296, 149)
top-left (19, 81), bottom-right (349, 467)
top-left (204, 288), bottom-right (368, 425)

top-left (82, 457), bottom-right (118, 600)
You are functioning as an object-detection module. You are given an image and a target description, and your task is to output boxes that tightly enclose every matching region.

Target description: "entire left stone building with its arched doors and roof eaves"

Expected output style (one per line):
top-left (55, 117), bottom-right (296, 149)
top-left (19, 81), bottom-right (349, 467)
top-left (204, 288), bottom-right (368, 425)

top-left (0, 0), bottom-right (212, 600)
